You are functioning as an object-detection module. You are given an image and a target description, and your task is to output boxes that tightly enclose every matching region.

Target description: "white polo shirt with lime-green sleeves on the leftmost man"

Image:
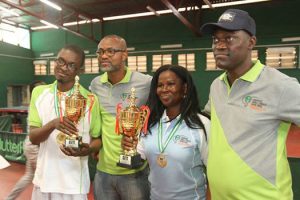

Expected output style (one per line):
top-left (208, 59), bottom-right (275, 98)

top-left (28, 81), bottom-right (101, 194)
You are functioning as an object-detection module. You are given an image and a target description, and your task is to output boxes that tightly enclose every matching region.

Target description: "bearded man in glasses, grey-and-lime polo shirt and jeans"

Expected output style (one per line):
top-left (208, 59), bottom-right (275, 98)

top-left (90, 35), bottom-right (152, 200)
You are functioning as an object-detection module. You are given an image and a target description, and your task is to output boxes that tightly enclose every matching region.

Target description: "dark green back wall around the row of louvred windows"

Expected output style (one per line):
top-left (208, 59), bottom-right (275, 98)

top-left (32, 0), bottom-right (300, 107)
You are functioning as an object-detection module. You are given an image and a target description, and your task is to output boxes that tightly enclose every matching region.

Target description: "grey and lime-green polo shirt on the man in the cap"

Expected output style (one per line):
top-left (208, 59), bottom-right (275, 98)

top-left (205, 61), bottom-right (300, 200)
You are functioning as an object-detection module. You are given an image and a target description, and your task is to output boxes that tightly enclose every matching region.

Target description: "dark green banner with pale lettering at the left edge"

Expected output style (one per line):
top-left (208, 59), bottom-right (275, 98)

top-left (0, 131), bottom-right (27, 163)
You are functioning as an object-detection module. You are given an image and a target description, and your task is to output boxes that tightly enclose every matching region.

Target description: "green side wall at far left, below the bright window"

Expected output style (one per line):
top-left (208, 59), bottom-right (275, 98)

top-left (0, 42), bottom-right (34, 107)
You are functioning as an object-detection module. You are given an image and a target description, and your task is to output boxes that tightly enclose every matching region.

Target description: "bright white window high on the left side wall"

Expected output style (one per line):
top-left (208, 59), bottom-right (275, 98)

top-left (0, 23), bottom-right (30, 49)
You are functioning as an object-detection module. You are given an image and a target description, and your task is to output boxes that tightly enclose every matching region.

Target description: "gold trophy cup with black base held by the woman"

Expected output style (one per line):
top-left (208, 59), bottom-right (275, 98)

top-left (116, 88), bottom-right (150, 169)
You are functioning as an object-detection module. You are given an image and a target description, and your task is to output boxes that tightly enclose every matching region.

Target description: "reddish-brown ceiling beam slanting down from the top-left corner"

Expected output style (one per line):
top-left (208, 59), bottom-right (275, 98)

top-left (0, 0), bottom-right (99, 44)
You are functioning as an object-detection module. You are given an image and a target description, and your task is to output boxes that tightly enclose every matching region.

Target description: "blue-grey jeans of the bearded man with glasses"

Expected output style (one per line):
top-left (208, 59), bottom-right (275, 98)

top-left (94, 168), bottom-right (150, 200)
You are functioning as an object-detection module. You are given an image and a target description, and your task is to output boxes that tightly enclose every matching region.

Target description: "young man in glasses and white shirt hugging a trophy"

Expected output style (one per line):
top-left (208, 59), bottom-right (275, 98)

top-left (28, 45), bottom-right (101, 200)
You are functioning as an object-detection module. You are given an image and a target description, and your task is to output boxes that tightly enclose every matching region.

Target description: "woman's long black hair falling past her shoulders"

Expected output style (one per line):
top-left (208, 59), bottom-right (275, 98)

top-left (147, 65), bottom-right (206, 138)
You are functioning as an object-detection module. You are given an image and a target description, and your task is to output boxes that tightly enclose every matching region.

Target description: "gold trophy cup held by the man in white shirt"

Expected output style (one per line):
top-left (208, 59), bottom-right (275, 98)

top-left (56, 76), bottom-right (86, 148)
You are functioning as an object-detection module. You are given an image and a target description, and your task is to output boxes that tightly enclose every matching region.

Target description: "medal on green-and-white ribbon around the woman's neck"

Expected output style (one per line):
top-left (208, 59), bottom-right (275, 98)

top-left (156, 119), bottom-right (181, 168)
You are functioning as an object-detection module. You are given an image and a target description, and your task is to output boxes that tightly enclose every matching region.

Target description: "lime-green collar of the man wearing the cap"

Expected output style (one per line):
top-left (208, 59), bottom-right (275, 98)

top-left (219, 60), bottom-right (264, 82)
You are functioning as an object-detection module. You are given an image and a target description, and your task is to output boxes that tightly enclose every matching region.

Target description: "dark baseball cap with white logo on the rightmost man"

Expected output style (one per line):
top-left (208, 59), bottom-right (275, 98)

top-left (200, 9), bottom-right (256, 35)
